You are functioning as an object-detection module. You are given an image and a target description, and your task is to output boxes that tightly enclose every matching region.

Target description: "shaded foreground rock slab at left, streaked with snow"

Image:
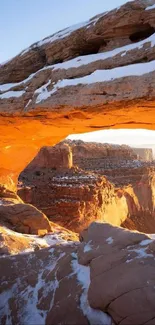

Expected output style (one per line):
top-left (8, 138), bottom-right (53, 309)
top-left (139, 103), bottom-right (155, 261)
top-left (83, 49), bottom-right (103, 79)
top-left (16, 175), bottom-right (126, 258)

top-left (0, 230), bottom-right (111, 325)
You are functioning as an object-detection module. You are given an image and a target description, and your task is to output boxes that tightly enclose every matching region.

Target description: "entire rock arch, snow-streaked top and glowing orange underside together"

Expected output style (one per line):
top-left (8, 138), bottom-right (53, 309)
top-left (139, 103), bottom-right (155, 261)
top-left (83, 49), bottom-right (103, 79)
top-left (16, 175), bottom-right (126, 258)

top-left (0, 0), bottom-right (155, 181)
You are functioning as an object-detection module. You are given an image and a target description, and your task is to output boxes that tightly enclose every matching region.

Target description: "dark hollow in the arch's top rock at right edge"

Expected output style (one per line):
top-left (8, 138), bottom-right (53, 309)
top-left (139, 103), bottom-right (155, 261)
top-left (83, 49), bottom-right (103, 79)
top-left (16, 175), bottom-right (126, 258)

top-left (129, 24), bottom-right (155, 43)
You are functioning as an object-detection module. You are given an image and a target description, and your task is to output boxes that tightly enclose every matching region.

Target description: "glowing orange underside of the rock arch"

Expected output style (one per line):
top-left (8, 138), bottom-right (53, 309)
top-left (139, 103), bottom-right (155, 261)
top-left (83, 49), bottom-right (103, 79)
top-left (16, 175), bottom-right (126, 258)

top-left (0, 101), bottom-right (155, 187)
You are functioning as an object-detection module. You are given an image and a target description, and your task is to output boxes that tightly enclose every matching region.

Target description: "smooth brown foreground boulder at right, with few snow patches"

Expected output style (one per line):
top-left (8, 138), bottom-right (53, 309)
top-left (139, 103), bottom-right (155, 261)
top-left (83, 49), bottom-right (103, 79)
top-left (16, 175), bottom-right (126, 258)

top-left (79, 223), bottom-right (155, 325)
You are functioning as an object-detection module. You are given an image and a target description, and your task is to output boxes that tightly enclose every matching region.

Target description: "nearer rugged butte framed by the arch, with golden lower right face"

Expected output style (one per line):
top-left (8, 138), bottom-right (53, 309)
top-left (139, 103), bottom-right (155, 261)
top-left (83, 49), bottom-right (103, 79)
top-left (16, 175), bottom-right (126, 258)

top-left (18, 143), bottom-right (128, 232)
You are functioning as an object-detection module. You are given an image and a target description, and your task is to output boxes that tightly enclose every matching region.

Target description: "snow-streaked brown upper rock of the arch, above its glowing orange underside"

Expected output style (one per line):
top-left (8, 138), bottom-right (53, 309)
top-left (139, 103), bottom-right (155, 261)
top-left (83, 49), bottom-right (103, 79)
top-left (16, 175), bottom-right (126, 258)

top-left (0, 0), bottom-right (155, 115)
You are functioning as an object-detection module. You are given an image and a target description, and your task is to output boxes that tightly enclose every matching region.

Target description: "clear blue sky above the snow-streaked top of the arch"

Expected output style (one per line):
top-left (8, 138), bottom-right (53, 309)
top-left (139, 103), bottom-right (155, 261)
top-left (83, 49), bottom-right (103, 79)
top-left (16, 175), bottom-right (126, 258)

top-left (0, 0), bottom-right (130, 63)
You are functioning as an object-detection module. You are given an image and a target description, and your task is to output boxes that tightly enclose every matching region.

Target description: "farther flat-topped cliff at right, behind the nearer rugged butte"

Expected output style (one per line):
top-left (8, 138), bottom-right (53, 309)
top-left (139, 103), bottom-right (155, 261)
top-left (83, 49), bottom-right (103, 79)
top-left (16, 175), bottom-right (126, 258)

top-left (63, 140), bottom-right (155, 233)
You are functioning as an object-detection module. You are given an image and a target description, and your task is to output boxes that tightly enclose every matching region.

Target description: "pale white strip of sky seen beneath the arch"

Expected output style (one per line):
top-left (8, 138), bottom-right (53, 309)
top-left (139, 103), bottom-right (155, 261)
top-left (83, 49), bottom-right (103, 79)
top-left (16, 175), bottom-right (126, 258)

top-left (68, 129), bottom-right (155, 154)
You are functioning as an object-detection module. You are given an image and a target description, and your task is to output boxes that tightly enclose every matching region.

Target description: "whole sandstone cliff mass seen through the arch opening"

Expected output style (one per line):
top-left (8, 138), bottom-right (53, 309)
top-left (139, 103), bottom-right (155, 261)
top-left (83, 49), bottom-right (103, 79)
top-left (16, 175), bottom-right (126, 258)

top-left (18, 140), bottom-right (155, 233)
